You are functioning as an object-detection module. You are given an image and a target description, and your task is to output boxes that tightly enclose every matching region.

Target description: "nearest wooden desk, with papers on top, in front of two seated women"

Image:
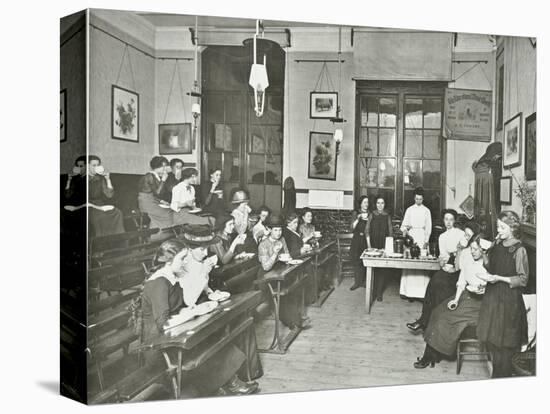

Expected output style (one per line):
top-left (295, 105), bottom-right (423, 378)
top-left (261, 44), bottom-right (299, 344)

top-left (137, 291), bottom-right (262, 398)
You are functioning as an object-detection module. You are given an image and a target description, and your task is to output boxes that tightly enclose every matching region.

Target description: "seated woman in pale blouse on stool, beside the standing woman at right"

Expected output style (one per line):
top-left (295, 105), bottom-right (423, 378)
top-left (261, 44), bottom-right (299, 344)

top-left (414, 235), bottom-right (491, 368)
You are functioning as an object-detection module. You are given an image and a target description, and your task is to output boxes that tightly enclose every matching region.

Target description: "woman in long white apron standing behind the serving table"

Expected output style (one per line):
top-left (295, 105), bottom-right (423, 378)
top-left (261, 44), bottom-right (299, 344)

top-left (399, 187), bottom-right (432, 299)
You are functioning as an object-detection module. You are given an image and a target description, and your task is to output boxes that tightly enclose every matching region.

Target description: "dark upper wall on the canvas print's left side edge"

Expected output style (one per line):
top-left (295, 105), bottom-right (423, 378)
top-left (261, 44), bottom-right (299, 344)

top-left (59, 12), bottom-right (86, 174)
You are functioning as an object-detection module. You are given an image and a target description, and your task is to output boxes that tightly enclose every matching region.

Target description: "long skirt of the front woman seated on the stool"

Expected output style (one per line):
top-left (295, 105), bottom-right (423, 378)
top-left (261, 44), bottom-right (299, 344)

top-left (424, 290), bottom-right (483, 355)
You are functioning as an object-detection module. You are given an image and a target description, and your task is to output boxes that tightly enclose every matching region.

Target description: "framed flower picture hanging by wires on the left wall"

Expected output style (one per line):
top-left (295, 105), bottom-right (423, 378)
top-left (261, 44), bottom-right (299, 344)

top-left (111, 85), bottom-right (139, 142)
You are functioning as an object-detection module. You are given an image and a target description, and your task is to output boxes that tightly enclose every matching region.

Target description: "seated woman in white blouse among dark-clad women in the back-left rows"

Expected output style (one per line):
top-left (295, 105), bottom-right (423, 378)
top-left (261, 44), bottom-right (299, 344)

top-left (170, 168), bottom-right (210, 225)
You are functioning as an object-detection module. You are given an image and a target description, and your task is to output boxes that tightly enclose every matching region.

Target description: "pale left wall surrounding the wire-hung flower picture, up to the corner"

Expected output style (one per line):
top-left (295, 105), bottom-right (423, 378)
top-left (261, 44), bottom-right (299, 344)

top-left (89, 11), bottom-right (156, 174)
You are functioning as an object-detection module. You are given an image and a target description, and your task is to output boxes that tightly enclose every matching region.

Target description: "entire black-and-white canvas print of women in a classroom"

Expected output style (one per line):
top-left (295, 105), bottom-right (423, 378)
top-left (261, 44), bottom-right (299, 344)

top-left (58, 5), bottom-right (542, 411)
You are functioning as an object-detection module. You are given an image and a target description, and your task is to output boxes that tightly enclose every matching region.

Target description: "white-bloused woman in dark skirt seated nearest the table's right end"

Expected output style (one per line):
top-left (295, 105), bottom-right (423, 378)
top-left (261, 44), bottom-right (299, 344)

top-left (407, 209), bottom-right (464, 331)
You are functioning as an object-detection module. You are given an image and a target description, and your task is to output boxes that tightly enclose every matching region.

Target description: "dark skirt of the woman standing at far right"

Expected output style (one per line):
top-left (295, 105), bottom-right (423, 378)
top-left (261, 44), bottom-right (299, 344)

top-left (477, 282), bottom-right (527, 348)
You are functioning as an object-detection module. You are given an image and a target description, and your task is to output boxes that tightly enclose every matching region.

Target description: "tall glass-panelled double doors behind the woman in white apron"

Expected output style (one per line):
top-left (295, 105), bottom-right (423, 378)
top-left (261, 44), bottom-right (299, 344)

top-left (355, 84), bottom-right (445, 219)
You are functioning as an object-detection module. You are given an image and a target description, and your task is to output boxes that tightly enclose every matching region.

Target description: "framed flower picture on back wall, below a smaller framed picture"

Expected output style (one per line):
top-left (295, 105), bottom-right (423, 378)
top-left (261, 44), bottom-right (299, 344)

top-left (307, 132), bottom-right (336, 180)
